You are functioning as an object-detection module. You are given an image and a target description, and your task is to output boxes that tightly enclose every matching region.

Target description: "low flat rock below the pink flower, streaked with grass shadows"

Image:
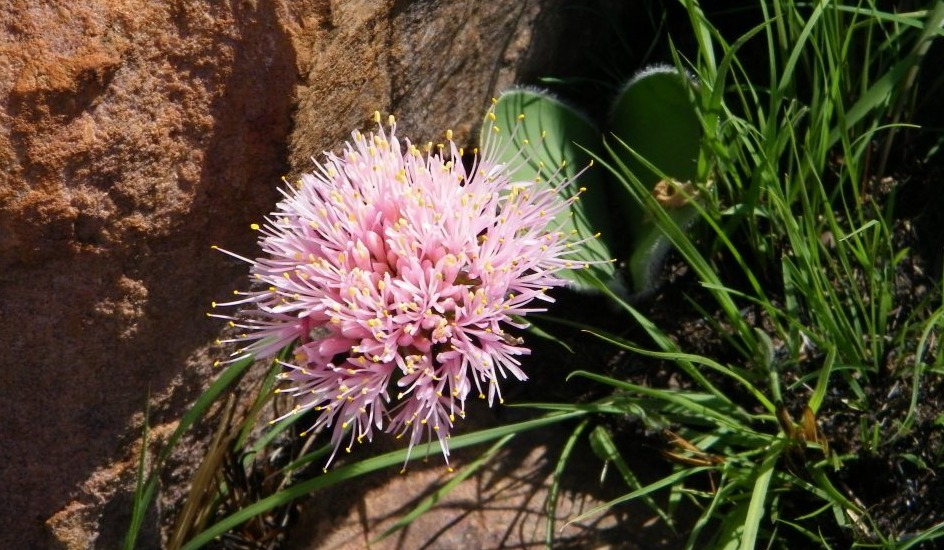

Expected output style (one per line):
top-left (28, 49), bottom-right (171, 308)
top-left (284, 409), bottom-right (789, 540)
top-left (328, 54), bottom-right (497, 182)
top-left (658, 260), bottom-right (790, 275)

top-left (287, 411), bottom-right (681, 550)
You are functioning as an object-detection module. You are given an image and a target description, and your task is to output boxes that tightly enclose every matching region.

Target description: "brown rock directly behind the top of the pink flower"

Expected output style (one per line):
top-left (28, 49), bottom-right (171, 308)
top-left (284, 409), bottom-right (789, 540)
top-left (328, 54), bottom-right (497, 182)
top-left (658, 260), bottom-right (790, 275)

top-left (290, 0), bottom-right (560, 171)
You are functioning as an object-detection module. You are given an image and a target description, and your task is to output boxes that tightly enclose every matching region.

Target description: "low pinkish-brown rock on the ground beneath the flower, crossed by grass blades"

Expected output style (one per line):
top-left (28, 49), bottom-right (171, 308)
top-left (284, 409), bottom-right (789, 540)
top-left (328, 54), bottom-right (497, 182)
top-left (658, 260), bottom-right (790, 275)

top-left (289, 447), bottom-right (636, 550)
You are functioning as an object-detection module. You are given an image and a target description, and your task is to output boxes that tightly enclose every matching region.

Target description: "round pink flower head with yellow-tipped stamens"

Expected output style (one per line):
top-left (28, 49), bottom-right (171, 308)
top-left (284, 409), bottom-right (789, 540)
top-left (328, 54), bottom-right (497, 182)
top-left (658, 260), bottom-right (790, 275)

top-left (214, 113), bottom-right (584, 463)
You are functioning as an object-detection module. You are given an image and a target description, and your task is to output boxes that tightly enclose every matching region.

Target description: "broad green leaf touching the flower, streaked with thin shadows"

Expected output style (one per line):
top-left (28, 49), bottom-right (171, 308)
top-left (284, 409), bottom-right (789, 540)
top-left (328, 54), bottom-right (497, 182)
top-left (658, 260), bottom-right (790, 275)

top-left (481, 89), bottom-right (616, 291)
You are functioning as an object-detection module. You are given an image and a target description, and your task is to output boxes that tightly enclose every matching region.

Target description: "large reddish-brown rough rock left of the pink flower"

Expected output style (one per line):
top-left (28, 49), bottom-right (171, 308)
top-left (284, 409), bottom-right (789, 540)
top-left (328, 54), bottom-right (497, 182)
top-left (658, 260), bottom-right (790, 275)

top-left (0, 0), bottom-right (312, 548)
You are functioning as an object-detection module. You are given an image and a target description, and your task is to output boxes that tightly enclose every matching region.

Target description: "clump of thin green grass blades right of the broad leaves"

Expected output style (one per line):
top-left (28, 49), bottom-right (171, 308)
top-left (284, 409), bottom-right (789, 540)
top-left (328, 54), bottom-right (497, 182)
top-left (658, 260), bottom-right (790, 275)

top-left (543, 0), bottom-right (944, 548)
